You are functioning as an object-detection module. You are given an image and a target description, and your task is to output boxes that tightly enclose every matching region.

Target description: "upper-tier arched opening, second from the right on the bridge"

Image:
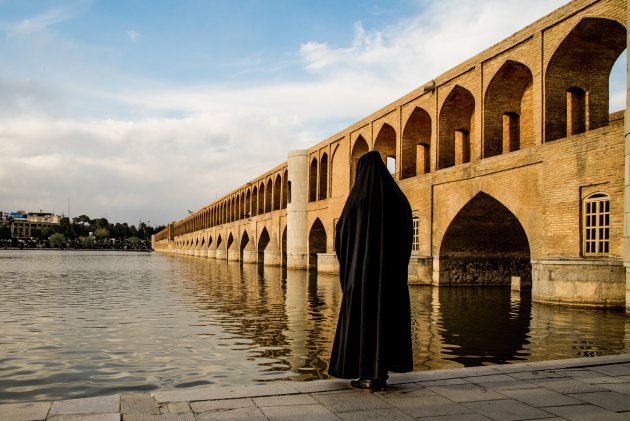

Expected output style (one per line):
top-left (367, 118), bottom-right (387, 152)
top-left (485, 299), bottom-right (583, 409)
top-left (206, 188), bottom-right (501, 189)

top-left (483, 60), bottom-right (534, 158)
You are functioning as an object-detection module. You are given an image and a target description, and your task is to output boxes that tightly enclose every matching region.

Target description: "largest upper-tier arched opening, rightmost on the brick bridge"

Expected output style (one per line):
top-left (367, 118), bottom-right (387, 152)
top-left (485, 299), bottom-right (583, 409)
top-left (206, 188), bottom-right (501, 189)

top-left (545, 17), bottom-right (626, 142)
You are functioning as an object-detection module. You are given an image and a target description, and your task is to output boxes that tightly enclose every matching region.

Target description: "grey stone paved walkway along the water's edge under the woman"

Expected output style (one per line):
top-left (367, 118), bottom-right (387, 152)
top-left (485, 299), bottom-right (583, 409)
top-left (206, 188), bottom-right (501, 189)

top-left (0, 354), bottom-right (630, 421)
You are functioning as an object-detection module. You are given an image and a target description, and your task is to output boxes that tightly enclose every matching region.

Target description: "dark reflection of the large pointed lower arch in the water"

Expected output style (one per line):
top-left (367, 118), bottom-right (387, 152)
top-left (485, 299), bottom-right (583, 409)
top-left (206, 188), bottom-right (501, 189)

top-left (439, 287), bottom-right (532, 367)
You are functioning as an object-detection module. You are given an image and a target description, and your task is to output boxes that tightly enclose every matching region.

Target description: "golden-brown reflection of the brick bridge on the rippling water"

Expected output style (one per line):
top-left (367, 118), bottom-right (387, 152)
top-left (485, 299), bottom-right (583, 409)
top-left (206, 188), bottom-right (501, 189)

top-left (164, 258), bottom-right (630, 381)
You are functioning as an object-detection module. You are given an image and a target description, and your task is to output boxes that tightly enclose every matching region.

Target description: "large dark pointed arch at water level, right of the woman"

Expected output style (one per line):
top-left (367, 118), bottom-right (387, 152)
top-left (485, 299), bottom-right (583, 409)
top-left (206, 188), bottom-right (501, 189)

top-left (439, 192), bottom-right (531, 286)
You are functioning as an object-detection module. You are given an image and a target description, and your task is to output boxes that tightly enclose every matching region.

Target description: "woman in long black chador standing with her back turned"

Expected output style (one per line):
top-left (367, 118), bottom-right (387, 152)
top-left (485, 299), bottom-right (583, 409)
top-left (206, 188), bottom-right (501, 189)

top-left (328, 152), bottom-right (413, 390)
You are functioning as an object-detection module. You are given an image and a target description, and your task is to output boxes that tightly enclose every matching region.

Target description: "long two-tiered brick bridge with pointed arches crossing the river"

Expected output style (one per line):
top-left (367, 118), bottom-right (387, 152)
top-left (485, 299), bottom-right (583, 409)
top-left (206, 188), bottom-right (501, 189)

top-left (153, 0), bottom-right (630, 313)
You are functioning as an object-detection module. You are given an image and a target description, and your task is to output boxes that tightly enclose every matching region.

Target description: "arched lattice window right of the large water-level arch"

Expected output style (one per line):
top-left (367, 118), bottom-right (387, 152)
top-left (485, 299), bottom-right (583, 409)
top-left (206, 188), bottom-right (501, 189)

top-left (582, 193), bottom-right (610, 256)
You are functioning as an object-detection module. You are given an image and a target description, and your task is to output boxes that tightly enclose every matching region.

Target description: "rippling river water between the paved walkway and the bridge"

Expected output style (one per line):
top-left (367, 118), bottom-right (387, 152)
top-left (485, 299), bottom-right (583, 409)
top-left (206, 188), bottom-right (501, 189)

top-left (0, 251), bottom-right (630, 403)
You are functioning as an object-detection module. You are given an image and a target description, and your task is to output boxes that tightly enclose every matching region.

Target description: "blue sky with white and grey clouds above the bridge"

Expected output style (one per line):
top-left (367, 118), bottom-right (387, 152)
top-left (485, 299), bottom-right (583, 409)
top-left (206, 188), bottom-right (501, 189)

top-left (0, 0), bottom-right (626, 226)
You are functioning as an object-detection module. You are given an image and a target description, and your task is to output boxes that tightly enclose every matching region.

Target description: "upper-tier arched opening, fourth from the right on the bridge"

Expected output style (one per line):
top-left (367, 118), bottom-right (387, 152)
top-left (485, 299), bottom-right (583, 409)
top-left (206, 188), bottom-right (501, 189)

top-left (400, 107), bottom-right (431, 180)
